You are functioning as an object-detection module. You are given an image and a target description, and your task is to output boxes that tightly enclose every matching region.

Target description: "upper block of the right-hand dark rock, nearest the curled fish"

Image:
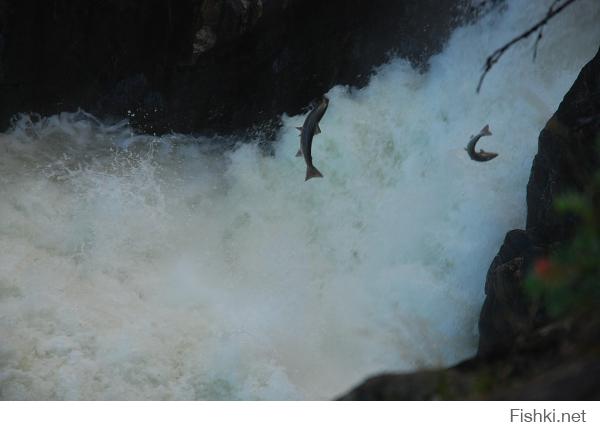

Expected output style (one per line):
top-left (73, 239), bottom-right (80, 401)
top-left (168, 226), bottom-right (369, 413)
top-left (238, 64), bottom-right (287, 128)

top-left (527, 47), bottom-right (600, 243)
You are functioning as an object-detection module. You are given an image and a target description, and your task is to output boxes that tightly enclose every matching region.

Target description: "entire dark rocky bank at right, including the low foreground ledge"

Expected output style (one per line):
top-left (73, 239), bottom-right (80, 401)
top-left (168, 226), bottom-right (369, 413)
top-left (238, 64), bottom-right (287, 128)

top-left (342, 46), bottom-right (600, 400)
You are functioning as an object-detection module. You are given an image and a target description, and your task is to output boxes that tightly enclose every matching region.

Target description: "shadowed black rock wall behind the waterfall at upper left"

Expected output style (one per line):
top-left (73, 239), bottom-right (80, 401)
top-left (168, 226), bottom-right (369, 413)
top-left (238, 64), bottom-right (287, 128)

top-left (0, 0), bottom-right (462, 133)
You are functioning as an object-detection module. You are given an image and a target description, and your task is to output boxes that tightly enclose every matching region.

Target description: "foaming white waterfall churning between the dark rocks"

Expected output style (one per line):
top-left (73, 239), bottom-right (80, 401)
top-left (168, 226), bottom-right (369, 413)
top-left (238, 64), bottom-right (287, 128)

top-left (0, 0), bottom-right (600, 399)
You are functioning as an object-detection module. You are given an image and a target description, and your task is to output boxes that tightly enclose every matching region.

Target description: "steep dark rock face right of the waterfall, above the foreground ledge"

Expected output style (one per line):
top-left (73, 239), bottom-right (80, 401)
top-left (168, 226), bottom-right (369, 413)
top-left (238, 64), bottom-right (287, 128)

top-left (479, 45), bottom-right (600, 356)
